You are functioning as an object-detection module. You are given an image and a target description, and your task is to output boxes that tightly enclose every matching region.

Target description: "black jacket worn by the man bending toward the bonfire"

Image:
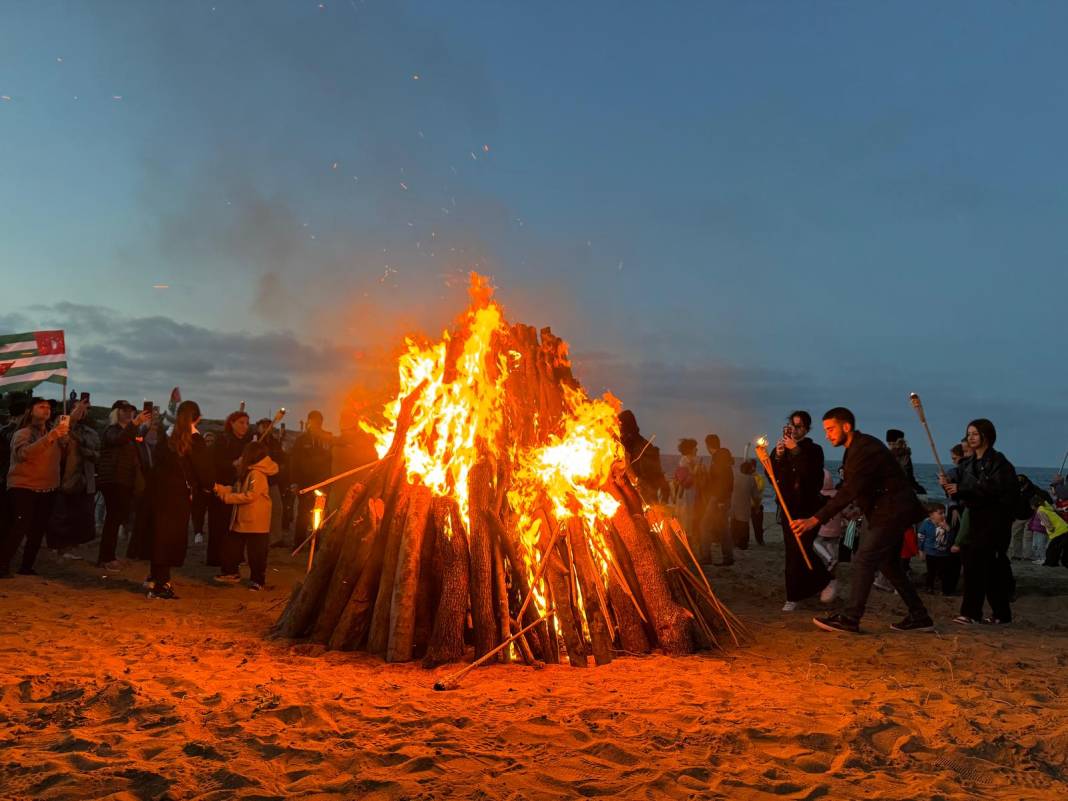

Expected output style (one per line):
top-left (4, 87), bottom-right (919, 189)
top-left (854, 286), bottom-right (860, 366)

top-left (815, 431), bottom-right (927, 531)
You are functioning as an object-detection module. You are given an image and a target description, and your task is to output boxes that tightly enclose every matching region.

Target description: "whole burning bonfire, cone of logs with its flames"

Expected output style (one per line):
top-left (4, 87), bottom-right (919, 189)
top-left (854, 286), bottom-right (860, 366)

top-left (274, 273), bottom-right (742, 668)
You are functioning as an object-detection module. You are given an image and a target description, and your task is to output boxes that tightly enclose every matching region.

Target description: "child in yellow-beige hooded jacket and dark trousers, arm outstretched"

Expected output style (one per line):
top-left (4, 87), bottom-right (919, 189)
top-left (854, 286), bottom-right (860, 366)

top-left (215, 442), bottom-right (278, 590)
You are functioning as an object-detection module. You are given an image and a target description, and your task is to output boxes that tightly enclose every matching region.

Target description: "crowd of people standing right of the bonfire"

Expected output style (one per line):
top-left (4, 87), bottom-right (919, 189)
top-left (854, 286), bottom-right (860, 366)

top-left (619, 407), bottom-right (1068, 631)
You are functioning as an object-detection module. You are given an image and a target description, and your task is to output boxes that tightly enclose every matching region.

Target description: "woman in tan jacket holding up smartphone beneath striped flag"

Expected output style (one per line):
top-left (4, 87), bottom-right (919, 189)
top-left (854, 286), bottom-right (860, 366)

top-left (0, 397), bottom-right (70, 578)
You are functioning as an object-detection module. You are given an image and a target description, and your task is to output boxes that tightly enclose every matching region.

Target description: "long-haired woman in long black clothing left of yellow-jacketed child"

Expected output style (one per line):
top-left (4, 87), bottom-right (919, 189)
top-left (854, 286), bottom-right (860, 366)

top-left (147, 401), bottom-right (211, 599)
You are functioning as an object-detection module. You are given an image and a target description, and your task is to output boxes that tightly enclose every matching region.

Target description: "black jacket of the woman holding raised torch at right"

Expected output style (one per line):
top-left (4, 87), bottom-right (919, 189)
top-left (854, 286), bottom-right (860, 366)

top-left (956, 447), bottom-right (1020, 550)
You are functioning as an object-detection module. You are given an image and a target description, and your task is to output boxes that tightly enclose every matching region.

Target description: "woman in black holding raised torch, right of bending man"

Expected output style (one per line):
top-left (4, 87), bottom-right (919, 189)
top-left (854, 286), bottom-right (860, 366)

top-left (941, 419), bottom-right (1021, 626)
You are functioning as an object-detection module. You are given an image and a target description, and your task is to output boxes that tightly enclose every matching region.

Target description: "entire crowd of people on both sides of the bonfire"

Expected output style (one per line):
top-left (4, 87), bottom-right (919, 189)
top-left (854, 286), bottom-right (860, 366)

top-left (0, 397), bottom-right (1068, 631)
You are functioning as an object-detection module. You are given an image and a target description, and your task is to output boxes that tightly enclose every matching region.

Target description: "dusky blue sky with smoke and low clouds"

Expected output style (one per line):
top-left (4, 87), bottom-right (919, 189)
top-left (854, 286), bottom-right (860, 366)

top-left (0, 0), bottom-right (1068, 466)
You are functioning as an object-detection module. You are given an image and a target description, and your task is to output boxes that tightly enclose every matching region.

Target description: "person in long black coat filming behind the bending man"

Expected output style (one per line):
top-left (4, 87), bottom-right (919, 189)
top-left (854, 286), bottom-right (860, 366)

top-left (770, 409), bottom-right (834, 612)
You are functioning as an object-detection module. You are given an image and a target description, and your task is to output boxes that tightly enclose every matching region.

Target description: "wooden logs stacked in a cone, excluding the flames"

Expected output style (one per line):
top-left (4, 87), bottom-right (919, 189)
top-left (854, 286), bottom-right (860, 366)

top-left (274, 326), bottom-right (743, 668)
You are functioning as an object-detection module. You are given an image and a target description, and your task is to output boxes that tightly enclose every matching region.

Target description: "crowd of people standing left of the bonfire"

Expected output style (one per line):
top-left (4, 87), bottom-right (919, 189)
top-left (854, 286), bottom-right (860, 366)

top-left (0, 397), bottom-right (377, 599)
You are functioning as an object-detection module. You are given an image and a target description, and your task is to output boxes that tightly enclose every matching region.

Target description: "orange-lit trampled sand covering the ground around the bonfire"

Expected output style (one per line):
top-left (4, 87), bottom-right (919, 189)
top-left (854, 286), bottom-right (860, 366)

top-left (0, 527), bottom-right (1068, 801)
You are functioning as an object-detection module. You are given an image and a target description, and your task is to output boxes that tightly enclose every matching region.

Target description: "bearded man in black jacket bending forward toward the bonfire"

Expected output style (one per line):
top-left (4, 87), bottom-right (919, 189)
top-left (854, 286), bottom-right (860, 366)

top-left (794, 407), bottom-right (935, 632)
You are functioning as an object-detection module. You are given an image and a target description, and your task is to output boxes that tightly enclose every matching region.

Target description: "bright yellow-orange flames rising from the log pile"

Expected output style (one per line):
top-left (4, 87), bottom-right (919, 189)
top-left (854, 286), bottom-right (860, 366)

top-left (360, 273), bottom-right (625, 611)
